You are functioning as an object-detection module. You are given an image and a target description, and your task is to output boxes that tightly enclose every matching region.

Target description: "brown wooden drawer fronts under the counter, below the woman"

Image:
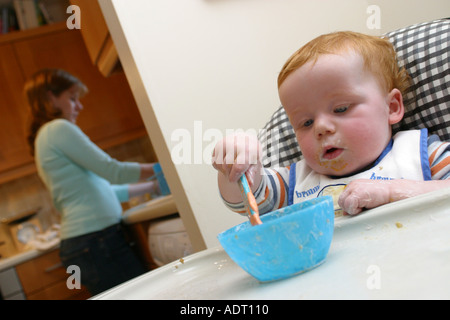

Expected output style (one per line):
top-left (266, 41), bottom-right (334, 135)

top-left (15, 250), bottom-right (90, 300)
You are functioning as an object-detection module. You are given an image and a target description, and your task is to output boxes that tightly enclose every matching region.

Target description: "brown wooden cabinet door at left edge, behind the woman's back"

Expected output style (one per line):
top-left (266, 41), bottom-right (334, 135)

top-left (0, 44), bottom-right (33, 172)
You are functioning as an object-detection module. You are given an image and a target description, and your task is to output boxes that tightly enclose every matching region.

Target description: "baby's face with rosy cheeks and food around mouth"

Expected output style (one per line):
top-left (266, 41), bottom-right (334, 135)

top-left (279, 53), bottom-right (391, 176)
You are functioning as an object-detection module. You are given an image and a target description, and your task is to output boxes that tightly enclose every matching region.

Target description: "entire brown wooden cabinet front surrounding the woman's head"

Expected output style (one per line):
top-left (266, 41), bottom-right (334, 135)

top-left (0, 22), bottom-right (146, 183)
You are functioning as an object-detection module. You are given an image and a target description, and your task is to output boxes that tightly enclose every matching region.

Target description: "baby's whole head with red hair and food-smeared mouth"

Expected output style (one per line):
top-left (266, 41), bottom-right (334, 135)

top-left (278, 32), bottom-right (409, 176)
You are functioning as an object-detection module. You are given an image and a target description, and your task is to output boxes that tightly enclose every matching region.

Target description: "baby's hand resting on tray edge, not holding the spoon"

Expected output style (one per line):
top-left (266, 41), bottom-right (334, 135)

top-left (338, 179), bottom-right (391, 215)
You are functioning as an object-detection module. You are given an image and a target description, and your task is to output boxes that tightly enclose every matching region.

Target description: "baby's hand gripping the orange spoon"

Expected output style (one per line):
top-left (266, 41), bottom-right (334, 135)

top-left (212, 133), bottom-right (261, 185)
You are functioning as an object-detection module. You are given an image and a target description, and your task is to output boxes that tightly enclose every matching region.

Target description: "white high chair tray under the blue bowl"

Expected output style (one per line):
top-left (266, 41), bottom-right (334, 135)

top-left (92, 189), bottom-right (450, 300)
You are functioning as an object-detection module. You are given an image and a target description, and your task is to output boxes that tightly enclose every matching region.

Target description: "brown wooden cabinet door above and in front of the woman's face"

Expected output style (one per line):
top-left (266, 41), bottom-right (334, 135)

top-left (13, 29), bottom-right (146, 148)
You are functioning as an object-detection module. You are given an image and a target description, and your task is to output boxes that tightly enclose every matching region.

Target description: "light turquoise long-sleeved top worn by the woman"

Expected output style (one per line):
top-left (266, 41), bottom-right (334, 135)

top-left (35, 119), bottom-right (140, 239)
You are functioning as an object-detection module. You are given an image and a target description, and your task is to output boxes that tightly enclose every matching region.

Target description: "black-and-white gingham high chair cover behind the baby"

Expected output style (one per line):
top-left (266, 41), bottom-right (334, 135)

top-left (258, 19), bottom-right (450, 167)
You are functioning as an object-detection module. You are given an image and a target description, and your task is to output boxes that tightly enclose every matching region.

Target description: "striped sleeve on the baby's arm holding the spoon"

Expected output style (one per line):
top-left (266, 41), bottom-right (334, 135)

top-left (222, 168), bottom-right (289, 216)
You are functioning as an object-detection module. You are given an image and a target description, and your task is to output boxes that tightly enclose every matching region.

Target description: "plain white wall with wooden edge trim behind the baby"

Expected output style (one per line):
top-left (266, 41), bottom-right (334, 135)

top-left (99, 0), bottom-right (450, 250)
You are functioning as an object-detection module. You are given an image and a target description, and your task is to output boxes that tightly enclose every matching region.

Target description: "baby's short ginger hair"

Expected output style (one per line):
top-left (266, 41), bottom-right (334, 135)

top-left (278, 31), bottom-right (410, 95)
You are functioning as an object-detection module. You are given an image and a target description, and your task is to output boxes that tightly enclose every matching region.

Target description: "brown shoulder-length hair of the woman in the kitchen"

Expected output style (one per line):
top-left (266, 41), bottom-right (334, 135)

top-left (24, 69), bottom-right (88, 155)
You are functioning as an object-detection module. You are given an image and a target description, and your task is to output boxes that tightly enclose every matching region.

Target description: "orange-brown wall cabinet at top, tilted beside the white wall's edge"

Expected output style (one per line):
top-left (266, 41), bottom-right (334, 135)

top-left (70, 0), bottom-right (118, 77)
